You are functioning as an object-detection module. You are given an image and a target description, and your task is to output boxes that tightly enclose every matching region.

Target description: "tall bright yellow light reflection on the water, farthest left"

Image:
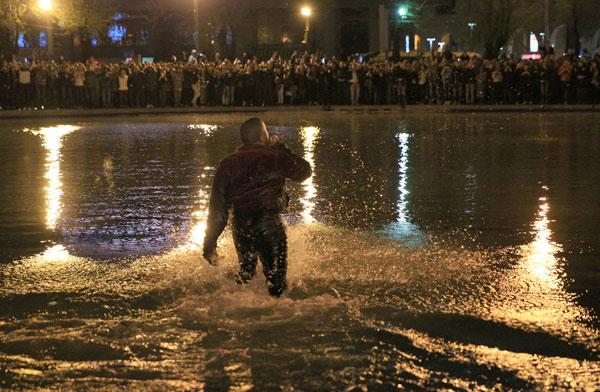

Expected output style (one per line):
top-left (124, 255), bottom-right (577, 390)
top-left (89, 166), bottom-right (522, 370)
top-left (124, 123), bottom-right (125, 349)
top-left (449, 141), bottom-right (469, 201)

top-left (27, 125), bottom-right (79, 230)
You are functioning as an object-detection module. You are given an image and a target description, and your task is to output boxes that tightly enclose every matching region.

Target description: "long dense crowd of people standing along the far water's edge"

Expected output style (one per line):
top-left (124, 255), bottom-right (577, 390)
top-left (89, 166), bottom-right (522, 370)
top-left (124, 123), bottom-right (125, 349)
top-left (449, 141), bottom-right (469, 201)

top-left (0, 51), bottom-right (600, 110)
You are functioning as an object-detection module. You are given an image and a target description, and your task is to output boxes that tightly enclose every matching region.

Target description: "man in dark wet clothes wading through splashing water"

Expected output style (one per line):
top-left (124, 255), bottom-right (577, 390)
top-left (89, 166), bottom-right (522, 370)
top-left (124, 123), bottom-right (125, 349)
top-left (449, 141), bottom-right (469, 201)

top-left (203, 118), bottom-right (312, 297)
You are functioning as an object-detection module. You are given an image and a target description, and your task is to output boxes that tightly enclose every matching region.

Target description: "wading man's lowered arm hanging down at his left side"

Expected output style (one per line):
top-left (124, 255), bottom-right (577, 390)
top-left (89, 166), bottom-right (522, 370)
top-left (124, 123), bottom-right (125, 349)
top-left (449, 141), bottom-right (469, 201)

top-left (203, 165), bottom-right (228, 261)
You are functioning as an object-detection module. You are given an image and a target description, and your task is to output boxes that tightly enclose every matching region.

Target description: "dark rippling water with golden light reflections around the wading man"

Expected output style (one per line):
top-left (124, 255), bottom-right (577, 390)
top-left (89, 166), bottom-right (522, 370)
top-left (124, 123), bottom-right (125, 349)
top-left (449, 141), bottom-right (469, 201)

top-left (0, 114), bottom-right (600, 391)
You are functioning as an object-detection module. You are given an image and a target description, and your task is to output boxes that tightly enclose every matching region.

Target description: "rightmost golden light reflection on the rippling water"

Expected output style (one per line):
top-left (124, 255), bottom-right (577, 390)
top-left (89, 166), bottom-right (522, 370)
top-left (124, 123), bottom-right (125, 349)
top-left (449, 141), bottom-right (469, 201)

top-left (526, 197), bottom-right (561, 288)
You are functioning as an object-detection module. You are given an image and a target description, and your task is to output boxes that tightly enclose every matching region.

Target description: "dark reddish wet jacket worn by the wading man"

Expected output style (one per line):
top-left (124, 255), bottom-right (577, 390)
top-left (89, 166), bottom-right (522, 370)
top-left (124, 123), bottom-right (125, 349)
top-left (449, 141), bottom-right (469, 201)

top-left (204, 144), bottom-right (312, 254)
